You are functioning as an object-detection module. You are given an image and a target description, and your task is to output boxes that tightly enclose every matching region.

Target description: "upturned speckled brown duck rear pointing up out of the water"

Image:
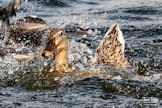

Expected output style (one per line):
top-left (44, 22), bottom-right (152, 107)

top-left (93, 24), bottom-right (130, 68)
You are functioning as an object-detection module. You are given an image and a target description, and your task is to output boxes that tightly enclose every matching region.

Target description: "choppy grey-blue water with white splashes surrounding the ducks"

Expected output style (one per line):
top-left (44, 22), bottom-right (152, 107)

top-left (0, 0), bottom-right (162, 108)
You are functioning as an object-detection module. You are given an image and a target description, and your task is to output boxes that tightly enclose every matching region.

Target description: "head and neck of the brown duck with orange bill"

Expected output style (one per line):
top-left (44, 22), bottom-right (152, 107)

top-left (42, 29), bottom-right (68, 65)
